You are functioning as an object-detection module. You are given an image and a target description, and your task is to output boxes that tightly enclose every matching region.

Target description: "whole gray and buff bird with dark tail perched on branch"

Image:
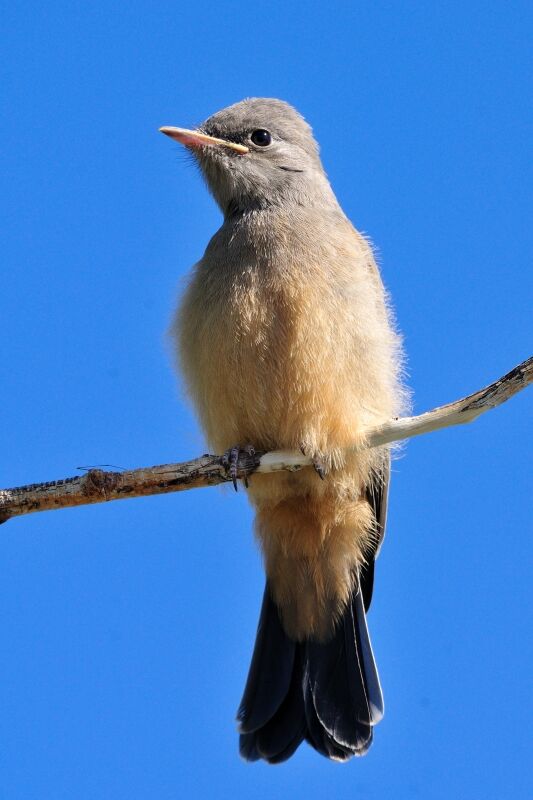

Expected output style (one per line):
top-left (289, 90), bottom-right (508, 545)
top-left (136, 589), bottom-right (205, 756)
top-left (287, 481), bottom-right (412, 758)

top-left (160, 97), bottom-right (408, 764)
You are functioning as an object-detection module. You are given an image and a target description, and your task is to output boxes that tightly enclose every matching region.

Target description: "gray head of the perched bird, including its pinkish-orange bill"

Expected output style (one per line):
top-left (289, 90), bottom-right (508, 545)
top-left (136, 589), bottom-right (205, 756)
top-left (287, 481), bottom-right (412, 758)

top-left (161, 97), bottom-right (335, 216)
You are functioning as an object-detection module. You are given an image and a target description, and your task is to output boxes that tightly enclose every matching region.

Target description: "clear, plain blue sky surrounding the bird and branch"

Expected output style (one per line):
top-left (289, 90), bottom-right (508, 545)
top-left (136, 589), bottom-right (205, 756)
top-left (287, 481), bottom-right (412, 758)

top-left (0, 0), bottom-right (533, 800)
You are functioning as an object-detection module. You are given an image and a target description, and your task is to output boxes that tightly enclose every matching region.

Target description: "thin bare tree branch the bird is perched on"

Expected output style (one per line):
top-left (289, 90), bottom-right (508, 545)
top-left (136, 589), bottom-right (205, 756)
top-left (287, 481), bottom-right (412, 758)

top-left (0, 357), bottom-right (533, 523)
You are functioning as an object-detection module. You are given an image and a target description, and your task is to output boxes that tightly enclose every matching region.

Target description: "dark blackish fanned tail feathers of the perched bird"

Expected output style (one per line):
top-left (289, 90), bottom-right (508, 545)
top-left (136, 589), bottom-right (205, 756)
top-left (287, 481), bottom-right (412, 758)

top-left (237, 583), bottom-right (383, 764)
